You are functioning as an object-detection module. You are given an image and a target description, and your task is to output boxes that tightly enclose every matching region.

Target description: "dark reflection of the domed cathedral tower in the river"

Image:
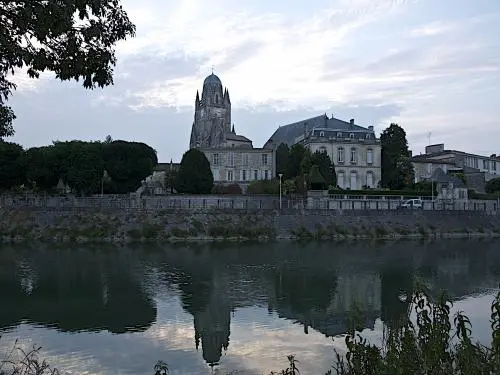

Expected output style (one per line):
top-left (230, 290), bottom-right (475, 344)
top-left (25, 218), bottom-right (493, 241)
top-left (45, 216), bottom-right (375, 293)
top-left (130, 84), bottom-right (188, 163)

top-left (194, 292), bottom-right (231, 366)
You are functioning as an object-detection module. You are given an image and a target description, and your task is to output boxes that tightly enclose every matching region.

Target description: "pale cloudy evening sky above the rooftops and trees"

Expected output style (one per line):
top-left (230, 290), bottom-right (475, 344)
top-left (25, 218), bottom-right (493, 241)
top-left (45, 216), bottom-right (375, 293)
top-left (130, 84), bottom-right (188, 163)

top-left (5, 0), bottom-right (500, 162)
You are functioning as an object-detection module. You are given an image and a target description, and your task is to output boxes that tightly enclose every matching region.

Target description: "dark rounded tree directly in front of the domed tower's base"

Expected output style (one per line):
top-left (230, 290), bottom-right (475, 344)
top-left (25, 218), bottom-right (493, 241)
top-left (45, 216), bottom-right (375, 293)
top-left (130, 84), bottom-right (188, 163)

top-left (175, 148), bottom-right (214, 194)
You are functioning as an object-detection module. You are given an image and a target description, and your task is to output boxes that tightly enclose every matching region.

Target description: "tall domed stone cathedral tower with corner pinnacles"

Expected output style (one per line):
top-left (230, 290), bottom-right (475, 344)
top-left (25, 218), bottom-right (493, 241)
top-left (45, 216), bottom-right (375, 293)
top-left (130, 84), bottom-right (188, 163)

top-left (189, 73), bottom-right (231, 148)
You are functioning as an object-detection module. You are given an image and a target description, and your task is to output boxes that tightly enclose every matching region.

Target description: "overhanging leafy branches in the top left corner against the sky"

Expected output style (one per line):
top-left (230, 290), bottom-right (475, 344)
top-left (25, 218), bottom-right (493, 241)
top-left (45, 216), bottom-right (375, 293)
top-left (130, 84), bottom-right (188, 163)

top-left (0, 0), bottom-right (135, 138)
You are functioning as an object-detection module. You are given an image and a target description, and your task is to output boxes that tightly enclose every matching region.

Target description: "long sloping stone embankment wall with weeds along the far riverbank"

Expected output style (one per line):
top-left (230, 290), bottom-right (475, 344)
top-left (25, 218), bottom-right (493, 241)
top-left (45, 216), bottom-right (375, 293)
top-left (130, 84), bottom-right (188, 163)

top-left (0, 207), bottom-right (500, 243)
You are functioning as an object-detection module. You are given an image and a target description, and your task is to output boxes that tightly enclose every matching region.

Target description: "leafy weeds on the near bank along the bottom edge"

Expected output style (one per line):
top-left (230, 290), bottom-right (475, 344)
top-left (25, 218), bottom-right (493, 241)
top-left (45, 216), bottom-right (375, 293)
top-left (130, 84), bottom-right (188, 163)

top-left (0, 287), bottom-right (500, 375)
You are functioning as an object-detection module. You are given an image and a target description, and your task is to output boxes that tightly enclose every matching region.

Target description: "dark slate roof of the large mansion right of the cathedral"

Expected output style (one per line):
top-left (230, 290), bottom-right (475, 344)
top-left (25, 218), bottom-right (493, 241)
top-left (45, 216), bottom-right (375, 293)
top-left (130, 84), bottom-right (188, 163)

top-left (264, 114), bottom-right (373, 148)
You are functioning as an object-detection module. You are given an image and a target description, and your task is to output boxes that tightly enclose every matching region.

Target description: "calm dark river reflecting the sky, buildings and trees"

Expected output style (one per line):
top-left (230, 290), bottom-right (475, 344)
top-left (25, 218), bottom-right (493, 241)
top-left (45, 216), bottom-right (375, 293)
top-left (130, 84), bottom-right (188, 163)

top-left (0, 240), bottom-right (500, 374)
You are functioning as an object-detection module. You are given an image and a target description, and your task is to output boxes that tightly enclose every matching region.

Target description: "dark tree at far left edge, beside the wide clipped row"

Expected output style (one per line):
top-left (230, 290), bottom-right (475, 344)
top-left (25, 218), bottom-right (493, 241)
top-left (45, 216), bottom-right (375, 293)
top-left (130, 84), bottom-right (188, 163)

top-left (0, 141), bottom-right (25, 189)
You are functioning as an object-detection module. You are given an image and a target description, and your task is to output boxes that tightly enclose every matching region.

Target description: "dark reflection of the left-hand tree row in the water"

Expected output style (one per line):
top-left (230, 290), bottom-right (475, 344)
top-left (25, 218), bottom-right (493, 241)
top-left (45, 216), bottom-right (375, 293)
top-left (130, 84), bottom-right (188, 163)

top-left (0, 251), bottom-right (156, 333)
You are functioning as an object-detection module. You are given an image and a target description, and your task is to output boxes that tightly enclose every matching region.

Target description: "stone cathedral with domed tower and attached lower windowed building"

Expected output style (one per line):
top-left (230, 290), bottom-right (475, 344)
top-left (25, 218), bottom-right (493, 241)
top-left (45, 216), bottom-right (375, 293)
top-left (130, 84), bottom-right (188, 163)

top-left (189, 73), bottom-right (276, 189)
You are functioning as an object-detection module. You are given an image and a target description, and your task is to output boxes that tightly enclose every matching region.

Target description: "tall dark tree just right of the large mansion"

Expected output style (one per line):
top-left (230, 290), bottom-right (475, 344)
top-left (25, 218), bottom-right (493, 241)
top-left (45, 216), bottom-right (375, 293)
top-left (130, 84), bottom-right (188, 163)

top-left (380, 123), bottom-right (414, 190)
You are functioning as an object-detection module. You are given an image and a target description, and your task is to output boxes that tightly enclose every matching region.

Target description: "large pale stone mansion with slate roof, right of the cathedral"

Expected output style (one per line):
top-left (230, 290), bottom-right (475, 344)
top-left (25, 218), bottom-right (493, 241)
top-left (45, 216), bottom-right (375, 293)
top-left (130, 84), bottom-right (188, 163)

top-left (264, 114), bottom-right (382, 190)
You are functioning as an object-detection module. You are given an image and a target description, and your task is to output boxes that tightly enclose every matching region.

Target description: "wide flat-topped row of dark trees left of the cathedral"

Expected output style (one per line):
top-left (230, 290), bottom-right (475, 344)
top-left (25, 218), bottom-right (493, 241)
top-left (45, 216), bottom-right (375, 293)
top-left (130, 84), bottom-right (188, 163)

top-left (18, 141), bottom-right (158, 195)
